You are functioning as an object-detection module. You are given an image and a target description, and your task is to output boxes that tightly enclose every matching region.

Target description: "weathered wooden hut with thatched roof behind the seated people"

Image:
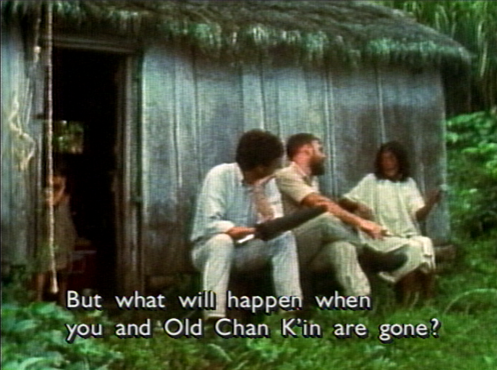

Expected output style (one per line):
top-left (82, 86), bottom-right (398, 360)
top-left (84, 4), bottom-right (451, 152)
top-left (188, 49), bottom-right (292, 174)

top-left (1, 1), bottom-right (469, 292)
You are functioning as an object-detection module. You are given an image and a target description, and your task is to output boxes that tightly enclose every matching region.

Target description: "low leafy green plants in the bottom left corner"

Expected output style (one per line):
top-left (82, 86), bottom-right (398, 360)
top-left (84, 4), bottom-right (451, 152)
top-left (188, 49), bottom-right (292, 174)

top-left (2, 301), bottom-right (119, 370)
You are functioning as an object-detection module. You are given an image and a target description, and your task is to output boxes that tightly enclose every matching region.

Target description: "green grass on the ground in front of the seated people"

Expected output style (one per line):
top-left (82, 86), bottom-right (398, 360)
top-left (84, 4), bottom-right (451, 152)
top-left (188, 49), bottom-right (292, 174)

top-left (105, 237), bottom-right (497, 370)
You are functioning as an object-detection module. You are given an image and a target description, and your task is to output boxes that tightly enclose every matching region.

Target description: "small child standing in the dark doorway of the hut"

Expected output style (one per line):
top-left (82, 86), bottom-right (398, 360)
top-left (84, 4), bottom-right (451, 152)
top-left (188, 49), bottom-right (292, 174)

top-left (35, 170), bottom-right (77, 306)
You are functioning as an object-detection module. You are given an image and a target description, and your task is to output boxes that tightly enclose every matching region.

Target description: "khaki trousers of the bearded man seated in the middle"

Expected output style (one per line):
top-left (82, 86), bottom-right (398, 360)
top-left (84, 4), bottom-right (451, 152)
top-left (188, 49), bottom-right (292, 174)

top-left (294, 213), bottom-right (371, 296)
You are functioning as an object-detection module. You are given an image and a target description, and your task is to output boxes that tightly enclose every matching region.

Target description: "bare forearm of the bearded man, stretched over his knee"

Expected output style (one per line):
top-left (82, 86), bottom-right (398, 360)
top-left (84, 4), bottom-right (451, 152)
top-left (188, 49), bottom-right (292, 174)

top-left (301, 193), bottom-right (383, 239)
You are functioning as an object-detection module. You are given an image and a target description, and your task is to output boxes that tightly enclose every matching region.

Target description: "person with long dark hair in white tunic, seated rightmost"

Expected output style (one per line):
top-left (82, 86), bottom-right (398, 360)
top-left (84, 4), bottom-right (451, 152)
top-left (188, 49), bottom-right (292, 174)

top-left (341, 141), bottom-right (440, 304)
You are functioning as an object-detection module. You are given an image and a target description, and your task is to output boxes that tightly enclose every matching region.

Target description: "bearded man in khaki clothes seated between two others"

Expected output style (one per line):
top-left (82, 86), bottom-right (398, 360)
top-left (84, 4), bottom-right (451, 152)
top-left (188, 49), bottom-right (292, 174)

top-left (276, 133), bottom-right (382, 296)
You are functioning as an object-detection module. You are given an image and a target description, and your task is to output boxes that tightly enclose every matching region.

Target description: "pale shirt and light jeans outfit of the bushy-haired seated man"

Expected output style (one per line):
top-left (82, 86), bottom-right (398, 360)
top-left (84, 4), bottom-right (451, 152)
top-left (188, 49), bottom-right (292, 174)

top-left (191, 163), bottom-right (302, 317)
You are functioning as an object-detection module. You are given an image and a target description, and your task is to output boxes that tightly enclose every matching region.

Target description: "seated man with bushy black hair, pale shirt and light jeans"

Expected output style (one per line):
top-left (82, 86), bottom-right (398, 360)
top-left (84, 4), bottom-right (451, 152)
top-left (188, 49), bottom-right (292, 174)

top-left (191, 130), bottom-right (302, 320)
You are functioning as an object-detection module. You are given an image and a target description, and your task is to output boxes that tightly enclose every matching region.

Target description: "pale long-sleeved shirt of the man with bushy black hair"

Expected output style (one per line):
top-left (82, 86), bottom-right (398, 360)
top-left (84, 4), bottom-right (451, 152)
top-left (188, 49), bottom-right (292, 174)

top-left (191, 163), bottom-right (283, 242)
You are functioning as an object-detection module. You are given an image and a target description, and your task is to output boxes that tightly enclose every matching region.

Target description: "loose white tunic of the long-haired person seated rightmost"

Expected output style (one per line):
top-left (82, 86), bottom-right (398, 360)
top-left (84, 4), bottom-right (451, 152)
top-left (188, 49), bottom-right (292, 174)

top-left (344, 174), bottom-right (435, 282)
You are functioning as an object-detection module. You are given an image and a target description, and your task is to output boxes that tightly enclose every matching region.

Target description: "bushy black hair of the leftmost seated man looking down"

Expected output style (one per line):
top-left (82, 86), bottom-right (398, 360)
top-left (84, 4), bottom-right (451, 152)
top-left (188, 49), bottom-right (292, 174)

top-left (236, 130), bottom-right (284, 171)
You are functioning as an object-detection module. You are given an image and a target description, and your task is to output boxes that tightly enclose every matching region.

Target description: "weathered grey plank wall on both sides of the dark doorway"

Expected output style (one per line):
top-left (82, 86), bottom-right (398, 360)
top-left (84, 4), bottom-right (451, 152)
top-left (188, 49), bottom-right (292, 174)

top-left (1, 27), bottom-right (449, 276)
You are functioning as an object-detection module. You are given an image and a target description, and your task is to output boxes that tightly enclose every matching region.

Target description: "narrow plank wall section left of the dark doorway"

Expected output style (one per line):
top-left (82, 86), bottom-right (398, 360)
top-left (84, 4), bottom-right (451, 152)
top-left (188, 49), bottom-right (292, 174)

top-left (1, 22), bottom-right (41, 265)
